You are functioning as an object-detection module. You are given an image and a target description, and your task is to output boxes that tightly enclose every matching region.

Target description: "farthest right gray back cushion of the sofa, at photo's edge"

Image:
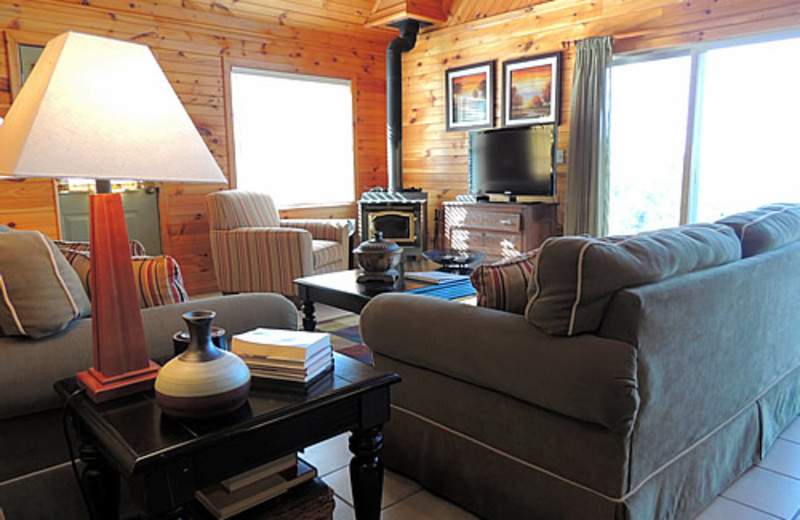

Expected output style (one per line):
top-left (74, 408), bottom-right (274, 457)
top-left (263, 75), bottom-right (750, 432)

top-left (717, 204), bottom-right (800, 258)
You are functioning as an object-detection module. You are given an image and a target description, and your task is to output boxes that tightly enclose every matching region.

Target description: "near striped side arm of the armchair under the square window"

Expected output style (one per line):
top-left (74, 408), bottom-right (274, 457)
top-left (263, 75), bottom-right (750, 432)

top-left (210, 227), bottom-right (313, 294)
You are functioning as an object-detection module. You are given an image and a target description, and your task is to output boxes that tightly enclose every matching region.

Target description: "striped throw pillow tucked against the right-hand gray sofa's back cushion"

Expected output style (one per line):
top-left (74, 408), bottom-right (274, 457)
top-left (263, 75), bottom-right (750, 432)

top-left (470, 249), bottom-right (539, 314)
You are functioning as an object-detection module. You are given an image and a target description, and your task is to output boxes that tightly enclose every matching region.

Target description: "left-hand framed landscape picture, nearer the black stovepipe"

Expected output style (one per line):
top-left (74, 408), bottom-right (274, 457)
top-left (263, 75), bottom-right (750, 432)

top-left (445, 61), bottom-right (494, 131)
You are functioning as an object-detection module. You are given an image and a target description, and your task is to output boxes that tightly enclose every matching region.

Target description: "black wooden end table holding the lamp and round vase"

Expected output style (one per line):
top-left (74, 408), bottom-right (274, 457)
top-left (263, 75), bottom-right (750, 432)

top-left (55, 354), bottom-right (400, 520)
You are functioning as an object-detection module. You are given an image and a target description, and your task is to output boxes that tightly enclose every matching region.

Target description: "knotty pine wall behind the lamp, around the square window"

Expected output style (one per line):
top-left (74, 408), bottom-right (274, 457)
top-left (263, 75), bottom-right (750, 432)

top-left (0, 0), bottom-right (395, 294)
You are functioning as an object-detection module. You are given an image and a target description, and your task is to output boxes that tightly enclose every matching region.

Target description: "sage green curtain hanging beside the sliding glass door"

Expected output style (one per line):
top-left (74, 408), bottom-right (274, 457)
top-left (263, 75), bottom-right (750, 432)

top-left (564, 36), bottom-right (613, 236)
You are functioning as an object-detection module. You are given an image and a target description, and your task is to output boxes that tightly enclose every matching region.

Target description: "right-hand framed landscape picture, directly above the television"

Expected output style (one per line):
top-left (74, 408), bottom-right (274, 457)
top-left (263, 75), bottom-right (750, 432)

top-left (503, 52), bottom-right (561, 126)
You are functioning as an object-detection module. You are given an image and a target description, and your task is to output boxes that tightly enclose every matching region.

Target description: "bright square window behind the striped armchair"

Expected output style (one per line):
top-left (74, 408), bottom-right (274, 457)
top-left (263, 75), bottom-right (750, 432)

top-left (231, 67), bottom-right (355, 207)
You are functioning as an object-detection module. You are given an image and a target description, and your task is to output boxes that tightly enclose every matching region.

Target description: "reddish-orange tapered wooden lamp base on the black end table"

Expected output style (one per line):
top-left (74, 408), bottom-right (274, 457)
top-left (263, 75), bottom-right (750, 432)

top-left (77, 193), bottom-right (159, 403)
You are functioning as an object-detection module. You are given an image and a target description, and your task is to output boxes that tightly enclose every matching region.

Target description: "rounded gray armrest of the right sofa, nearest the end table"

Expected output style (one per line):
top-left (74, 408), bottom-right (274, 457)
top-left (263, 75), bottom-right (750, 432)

top-left (360, 294), bottom-right (639, 434)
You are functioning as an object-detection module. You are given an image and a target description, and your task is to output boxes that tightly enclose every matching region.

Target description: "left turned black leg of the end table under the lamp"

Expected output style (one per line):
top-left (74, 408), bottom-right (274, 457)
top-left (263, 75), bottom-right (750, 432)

top-left (80, 443), bottom-right (119, 520)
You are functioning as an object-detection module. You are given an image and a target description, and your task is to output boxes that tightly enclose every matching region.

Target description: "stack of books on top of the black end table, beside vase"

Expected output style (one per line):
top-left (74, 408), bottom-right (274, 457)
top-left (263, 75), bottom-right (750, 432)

top-left (231, 328), bottom-right (333, 384)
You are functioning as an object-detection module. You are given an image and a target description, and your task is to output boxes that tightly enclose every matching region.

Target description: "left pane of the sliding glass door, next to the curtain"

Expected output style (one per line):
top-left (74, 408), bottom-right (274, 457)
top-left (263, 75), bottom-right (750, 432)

top-left (608, 57), bottom-right (691, 233)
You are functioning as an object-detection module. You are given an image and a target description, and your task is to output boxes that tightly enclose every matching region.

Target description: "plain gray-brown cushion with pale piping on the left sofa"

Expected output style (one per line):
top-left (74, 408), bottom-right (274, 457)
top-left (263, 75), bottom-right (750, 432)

top-left (0, 231), bottom-right (91, 338)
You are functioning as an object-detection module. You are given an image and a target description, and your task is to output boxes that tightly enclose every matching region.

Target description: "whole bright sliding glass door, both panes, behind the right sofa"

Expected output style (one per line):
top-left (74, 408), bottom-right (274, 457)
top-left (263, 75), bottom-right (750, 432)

top-left (609, 34), bottom-right (800, 234)
